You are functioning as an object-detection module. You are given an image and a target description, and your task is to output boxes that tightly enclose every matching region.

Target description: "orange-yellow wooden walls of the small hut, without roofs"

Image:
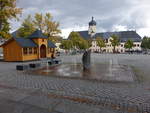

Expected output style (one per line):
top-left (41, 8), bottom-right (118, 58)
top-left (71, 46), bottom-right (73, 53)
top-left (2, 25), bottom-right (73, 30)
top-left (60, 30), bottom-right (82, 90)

top-left (3, 39), bottom-right (55, 61)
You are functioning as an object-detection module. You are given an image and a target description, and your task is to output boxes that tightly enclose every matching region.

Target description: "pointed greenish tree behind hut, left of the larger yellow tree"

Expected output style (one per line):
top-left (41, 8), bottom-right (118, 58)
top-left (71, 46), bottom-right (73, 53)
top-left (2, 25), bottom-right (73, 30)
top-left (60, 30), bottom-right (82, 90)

top-left (17, 15), bottom-right (36, 37)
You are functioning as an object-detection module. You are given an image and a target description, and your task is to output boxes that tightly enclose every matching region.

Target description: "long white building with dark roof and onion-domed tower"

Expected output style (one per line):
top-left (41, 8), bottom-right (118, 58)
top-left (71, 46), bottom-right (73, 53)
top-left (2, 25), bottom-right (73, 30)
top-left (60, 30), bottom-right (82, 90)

top-left (73, 17), bottom-right (142, 53)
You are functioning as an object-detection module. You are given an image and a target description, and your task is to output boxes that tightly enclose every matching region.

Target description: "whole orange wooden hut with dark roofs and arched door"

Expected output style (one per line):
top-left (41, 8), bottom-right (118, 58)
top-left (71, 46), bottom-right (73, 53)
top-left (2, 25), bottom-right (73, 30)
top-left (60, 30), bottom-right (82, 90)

top-left (2, 30), bottom-right (56, 61)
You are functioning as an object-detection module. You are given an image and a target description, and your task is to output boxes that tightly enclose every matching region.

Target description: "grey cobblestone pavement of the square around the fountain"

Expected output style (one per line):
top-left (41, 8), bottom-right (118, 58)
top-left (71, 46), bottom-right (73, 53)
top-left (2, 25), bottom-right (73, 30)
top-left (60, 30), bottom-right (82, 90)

top-left (0, 55), bottom-right (150, 113)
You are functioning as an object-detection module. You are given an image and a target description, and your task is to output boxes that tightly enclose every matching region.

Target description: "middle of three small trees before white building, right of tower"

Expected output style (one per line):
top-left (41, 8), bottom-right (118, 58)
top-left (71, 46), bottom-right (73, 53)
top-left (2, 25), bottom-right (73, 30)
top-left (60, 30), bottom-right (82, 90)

top-left (110, 35), bottom-right (120, 53)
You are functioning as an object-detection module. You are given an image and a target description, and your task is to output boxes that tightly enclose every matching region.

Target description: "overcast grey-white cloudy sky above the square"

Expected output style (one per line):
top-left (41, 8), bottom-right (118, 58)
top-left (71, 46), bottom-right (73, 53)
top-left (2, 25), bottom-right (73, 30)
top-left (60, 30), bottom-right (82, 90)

top-left (11, 0), bottom-right (150, 37)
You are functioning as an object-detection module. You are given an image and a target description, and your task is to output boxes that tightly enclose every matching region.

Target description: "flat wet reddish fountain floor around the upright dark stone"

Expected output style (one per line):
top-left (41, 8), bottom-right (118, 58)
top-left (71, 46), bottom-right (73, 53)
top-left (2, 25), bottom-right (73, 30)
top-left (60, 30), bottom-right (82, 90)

top-left (28, 64), bottom-right (134, 82)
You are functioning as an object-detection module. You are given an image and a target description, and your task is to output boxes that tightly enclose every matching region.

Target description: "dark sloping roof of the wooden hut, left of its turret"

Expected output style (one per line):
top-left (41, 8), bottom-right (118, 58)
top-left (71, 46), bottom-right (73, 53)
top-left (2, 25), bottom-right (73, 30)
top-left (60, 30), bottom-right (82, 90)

top-left (14, 38), bottom-right (38, 47)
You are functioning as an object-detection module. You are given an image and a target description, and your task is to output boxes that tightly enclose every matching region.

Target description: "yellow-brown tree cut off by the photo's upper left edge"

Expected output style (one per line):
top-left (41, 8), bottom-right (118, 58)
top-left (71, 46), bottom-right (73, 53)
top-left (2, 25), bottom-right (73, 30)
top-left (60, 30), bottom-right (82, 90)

top-left (0, 0), bottom-right (22, 38)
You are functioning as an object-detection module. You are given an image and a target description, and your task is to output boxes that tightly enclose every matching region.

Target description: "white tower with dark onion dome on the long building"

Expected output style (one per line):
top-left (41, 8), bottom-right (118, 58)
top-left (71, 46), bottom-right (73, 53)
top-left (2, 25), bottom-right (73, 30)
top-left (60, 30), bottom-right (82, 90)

top-left (88, 17), bottom-right (96, 37)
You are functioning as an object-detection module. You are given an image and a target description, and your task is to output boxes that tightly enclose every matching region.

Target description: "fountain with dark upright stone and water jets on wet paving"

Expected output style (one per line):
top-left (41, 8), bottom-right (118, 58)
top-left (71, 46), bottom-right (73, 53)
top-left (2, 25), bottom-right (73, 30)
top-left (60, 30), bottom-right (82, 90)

top-left (28, 50), bottom-right (134, 82)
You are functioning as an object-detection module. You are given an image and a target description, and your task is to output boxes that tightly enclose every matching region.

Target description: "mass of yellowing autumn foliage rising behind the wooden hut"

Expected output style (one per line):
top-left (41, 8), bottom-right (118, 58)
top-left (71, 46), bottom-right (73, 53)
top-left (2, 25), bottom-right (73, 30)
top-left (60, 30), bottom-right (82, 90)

top-left (19, 13), bottom-right (61, 40)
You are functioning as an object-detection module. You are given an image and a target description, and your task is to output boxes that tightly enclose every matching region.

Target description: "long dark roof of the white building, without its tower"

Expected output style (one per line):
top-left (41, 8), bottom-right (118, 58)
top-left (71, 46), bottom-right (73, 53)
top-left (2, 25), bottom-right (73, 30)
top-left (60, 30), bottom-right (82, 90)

top-left (77, 31), bottom-right (141, 42)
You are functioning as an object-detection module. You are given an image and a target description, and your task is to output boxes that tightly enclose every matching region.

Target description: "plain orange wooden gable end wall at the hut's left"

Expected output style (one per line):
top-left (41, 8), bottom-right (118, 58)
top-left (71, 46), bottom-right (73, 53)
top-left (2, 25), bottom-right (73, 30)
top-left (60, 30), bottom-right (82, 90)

top-left (3, 40), bottom-right (22, 61)
